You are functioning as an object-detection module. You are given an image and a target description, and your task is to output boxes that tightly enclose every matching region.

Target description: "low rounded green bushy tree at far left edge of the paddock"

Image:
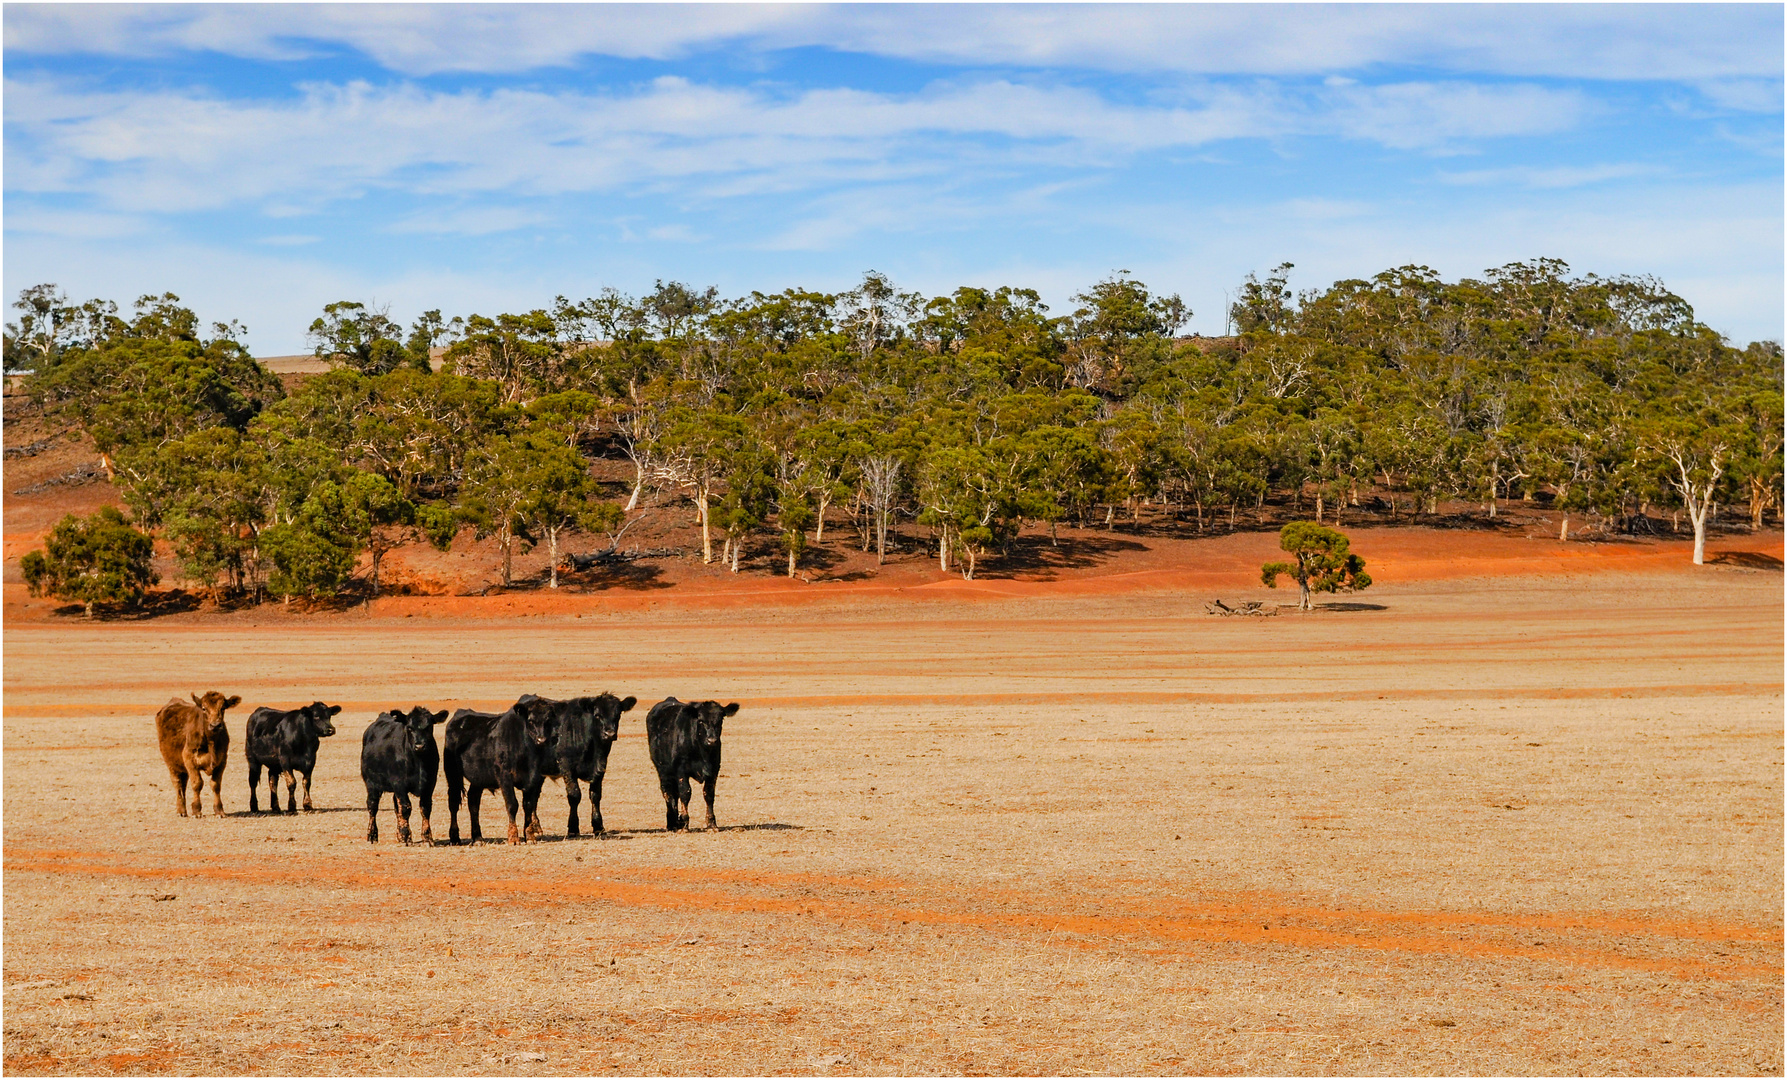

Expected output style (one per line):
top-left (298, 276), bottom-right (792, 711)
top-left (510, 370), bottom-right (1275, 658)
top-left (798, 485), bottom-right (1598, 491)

top-left (20, 506), bottom-right (161, 619)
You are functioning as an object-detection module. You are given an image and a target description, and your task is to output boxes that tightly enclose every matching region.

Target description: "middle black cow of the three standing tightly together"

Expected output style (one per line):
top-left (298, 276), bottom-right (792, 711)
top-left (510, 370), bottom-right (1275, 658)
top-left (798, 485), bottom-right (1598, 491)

top-left (441, 701), bottom-right (549, 844)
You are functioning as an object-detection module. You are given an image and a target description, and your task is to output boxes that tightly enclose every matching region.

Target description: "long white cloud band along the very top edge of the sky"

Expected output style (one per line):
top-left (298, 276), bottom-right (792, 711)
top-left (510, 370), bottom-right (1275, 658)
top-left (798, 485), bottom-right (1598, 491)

top-left (5, 4), bottom-right (1782, 81)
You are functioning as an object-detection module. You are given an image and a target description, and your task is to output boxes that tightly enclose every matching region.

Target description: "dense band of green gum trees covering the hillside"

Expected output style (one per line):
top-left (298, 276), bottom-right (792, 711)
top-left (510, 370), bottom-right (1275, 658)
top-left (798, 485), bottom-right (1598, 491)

top-left (5, 259), bottom-right (1782, 597)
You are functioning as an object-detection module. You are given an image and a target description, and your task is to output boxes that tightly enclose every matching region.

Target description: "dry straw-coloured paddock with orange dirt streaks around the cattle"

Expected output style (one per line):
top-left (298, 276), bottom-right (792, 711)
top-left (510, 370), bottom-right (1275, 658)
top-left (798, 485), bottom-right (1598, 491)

top-left (4, 561), bottom-right (1783, 1075)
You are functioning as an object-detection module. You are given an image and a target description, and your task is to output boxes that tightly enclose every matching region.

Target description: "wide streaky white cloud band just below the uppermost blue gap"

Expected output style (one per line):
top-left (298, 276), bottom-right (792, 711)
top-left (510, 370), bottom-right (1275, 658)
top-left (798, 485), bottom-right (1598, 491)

top-left (5, 77), bottom-right (1589, 213)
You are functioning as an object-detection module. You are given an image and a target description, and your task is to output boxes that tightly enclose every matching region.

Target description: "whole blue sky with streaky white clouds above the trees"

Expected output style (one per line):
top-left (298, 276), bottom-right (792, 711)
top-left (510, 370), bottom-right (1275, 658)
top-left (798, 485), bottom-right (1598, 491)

top-left (4, 4), bottom-right (1783, 356)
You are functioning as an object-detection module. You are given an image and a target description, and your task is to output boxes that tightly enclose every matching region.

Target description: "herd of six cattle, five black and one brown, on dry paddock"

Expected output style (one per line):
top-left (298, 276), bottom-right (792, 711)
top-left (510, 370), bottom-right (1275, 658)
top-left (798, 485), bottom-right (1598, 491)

top-left (155, 690), bottom-right (738, 844)
